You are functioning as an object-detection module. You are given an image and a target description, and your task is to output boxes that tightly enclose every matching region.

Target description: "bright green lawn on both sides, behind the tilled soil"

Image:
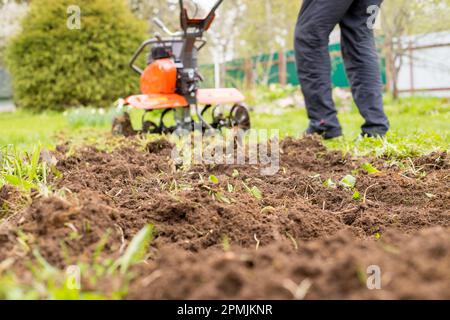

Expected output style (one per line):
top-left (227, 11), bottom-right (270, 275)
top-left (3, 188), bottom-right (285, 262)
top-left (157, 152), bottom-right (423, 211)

top-left (0, 97), bottom-right (450, 157)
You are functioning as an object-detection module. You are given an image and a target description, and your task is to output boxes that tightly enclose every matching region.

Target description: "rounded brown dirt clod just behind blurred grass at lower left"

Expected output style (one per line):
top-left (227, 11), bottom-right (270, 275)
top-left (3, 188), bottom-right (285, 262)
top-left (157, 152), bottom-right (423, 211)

top-left (10, 192), bottom-right (123, 267)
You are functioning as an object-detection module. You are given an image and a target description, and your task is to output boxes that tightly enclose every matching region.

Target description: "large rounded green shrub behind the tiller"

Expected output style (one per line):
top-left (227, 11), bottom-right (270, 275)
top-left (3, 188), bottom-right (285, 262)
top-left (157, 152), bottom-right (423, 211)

top-left (7, 0), bottom-right (146, 111)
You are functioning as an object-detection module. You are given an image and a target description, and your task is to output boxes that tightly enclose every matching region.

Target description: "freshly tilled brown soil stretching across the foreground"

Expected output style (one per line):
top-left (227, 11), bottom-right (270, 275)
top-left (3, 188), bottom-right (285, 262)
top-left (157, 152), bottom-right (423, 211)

top-left (0, 138), bottom-right (450, 299)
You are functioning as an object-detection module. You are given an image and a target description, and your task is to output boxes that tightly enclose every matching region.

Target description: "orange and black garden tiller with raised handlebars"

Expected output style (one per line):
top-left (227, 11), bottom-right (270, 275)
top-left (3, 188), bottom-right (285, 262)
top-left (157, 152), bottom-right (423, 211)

top-left (113, 0), bottom-right (250, 134)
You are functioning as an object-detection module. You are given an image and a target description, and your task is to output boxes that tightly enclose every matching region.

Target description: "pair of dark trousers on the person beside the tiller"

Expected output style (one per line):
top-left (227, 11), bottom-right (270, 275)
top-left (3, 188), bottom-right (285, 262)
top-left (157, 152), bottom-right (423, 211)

top-left (295, 0), bottom-right (389, 137)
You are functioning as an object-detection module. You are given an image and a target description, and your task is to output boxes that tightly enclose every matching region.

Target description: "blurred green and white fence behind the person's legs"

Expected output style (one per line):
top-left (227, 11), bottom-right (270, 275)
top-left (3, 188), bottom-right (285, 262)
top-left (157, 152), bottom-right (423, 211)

top-left (201, 32), bottom-right (450, 97)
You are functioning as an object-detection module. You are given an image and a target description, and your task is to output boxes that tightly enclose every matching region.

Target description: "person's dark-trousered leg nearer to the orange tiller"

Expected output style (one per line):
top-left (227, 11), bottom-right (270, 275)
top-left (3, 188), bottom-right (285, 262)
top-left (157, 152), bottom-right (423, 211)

top-left (294, 0), bottom-right (354, 138)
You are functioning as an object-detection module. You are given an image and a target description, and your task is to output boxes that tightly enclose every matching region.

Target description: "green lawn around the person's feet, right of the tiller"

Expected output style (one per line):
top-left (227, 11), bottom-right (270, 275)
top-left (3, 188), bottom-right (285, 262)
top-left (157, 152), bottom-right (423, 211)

top-left (252, 97), bottom-right (450, 158)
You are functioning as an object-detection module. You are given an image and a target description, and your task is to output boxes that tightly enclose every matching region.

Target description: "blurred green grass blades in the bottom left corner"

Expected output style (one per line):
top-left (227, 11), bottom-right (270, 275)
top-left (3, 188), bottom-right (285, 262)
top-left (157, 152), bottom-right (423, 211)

top-left (0, 225), bottom-right (154, 300)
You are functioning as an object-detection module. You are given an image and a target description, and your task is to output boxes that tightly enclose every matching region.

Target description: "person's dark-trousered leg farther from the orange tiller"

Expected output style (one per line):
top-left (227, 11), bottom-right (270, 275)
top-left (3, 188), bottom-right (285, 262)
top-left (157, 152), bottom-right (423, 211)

top-left (340, 0), bottom-right (389, 136)
